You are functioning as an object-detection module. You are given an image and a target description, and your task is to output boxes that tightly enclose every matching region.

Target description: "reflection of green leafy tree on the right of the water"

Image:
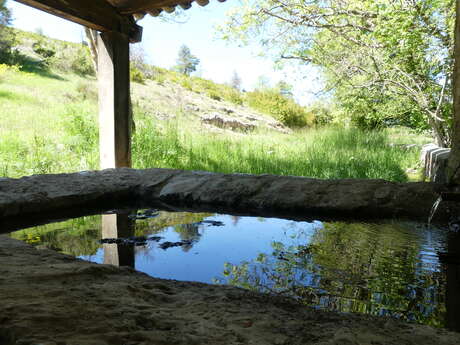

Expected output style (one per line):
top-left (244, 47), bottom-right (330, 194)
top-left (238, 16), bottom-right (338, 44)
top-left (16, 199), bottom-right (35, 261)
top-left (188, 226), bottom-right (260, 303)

top-left (219, 223), bottom-right (445, 326)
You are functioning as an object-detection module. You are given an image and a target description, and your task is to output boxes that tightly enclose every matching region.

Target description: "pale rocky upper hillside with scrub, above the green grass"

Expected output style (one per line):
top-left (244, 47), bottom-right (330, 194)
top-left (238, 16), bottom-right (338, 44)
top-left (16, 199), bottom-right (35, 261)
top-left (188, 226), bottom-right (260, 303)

top-left (6, 30), bottom-right (288, 132)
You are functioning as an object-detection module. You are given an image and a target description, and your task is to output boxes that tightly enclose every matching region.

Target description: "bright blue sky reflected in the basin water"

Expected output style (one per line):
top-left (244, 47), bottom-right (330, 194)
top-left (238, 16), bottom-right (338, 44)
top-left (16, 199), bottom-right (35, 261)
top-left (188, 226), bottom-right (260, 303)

top-left (80, 215), bottom-right (321, 283)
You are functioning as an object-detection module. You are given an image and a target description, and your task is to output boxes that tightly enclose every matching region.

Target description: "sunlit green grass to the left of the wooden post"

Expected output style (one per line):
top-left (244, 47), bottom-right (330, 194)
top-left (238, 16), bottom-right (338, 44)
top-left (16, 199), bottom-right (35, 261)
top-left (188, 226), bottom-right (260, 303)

top-left (0, 67), bottom-right (98, 177)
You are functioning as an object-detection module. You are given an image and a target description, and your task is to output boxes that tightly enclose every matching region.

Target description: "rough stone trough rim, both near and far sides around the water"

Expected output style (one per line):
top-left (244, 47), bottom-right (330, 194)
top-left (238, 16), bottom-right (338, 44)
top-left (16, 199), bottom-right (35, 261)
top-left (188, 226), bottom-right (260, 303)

top-left (0, 168), bottom-right (460, 345)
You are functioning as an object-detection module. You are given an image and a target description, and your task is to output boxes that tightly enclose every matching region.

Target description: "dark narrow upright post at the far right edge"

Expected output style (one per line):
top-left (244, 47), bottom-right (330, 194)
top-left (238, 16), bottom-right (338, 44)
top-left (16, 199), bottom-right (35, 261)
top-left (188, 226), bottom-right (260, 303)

top-left (448, 1), bottom-right (460, 185)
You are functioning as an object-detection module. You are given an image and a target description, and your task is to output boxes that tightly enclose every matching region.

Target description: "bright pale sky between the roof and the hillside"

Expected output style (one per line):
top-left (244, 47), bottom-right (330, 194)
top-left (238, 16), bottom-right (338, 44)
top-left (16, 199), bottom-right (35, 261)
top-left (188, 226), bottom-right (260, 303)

top-left (7, 0), bottom-right (319, 104)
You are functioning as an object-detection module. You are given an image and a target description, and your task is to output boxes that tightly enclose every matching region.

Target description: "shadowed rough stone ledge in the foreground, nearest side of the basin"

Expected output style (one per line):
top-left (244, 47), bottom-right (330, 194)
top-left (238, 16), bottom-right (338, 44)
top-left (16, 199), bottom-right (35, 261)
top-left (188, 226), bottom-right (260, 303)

top-left (0, 236), bottom-right (460, 345)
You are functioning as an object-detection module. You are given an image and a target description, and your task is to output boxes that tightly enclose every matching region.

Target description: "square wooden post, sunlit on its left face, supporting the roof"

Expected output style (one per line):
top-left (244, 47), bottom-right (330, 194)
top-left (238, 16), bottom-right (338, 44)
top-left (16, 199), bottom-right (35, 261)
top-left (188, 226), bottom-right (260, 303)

top-left (97, 31), bottom-right (132, 169)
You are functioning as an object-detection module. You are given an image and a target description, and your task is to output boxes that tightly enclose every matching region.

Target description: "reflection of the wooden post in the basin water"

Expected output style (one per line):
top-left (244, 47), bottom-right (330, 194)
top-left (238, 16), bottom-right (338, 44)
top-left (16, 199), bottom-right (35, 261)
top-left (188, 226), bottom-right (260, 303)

top-left (101, 212), bottom-right (135, 268)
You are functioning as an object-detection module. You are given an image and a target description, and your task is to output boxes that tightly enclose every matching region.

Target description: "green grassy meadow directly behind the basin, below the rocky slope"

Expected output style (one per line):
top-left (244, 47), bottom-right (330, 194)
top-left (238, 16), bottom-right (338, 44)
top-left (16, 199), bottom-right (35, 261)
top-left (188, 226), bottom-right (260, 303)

top-left (0, 59), bottom-right (429, 181)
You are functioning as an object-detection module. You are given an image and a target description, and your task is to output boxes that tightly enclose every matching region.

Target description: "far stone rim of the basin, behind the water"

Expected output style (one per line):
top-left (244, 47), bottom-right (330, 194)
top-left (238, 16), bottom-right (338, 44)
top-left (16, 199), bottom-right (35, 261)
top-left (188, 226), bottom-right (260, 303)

top-left (0, 168), bottom-right (455, 232)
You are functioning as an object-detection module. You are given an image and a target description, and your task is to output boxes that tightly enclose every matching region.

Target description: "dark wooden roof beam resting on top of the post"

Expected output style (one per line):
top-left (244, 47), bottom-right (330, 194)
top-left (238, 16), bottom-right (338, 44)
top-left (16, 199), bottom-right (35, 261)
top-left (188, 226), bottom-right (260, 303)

top-left (16, 0), bottom-right (142, 43)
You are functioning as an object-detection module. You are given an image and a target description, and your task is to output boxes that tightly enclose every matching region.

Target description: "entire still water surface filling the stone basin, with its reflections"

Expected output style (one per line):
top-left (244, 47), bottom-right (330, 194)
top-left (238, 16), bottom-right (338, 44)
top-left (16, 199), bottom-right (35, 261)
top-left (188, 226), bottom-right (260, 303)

top-left (11, 210), bottom-right (460, 328)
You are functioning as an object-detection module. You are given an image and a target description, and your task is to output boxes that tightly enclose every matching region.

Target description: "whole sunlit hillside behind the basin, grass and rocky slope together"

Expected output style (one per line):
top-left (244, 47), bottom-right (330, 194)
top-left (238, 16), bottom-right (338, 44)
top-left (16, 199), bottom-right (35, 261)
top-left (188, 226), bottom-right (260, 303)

top-left (0, 28), bottom-right (424, 181)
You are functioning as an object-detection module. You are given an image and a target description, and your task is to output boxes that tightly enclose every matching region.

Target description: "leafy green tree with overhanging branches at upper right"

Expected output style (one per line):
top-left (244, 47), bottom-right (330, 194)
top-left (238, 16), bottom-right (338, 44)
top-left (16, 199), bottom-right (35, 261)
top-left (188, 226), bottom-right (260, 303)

top-left (222, 0), bottom-right (455, 146)
